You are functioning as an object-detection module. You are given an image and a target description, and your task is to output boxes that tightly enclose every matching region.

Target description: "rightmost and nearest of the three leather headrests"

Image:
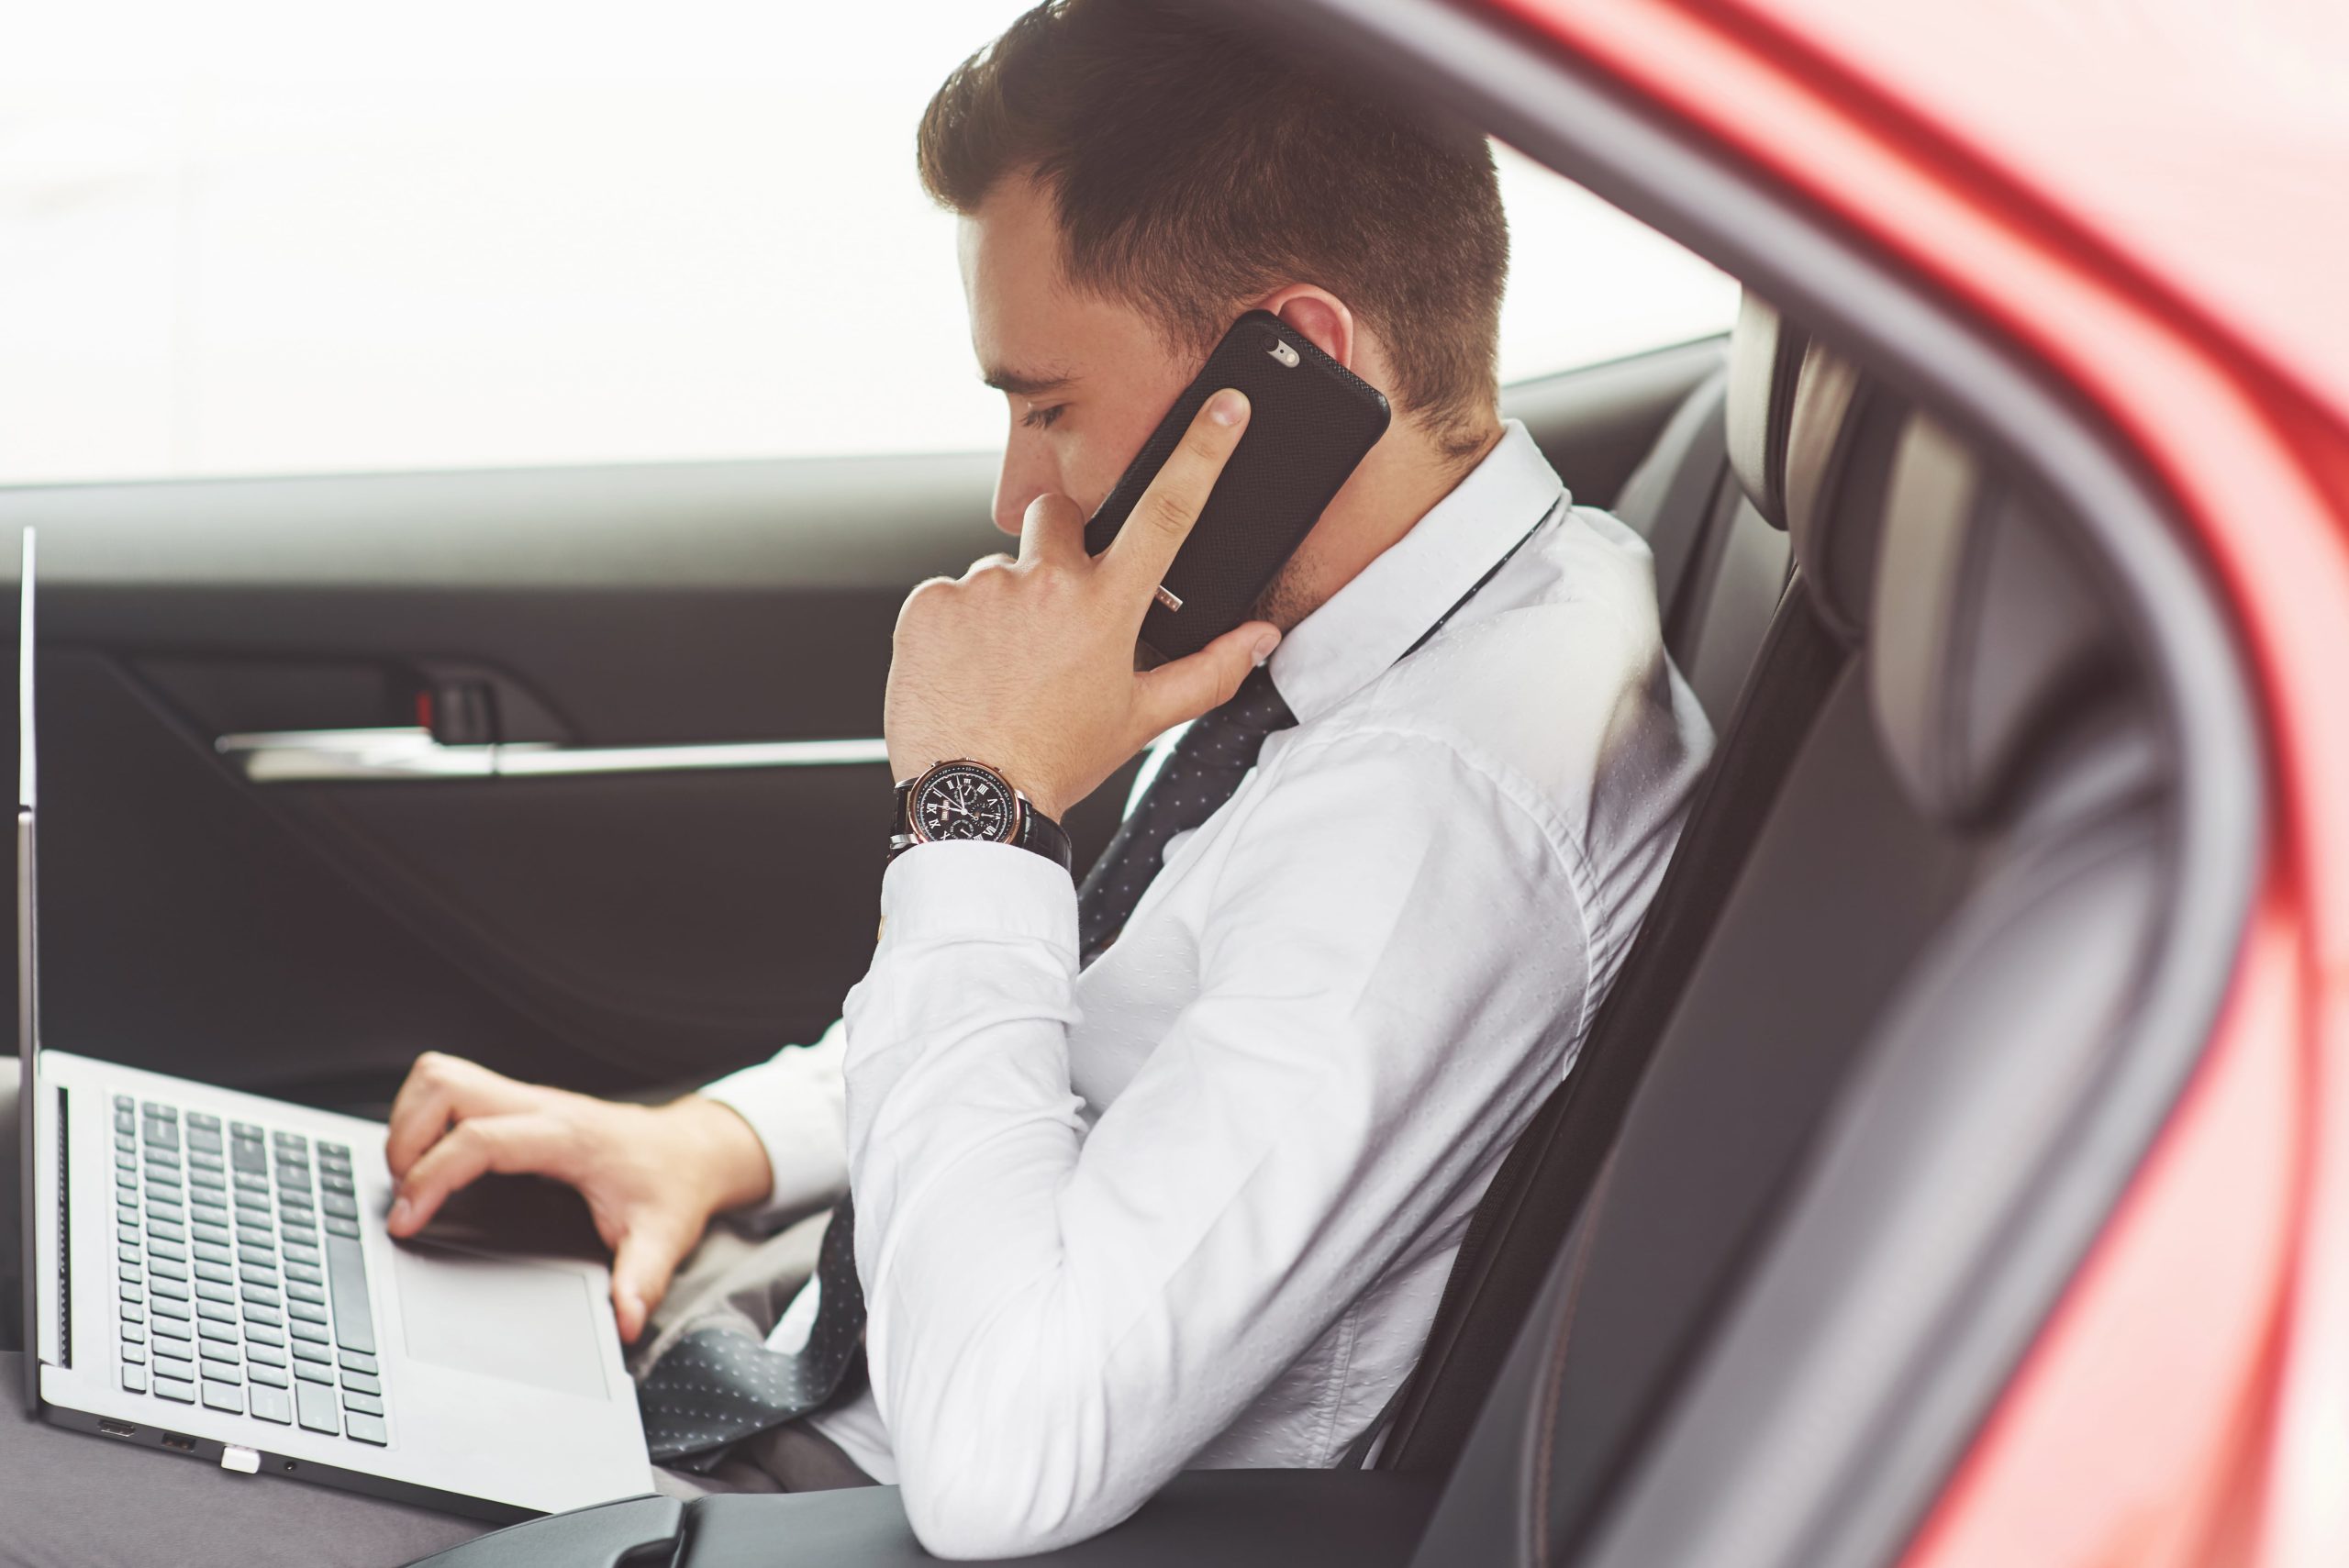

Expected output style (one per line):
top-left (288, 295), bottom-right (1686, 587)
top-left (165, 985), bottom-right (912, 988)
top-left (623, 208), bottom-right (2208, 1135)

top-left (1867, 417), bottom-right (2123, 827)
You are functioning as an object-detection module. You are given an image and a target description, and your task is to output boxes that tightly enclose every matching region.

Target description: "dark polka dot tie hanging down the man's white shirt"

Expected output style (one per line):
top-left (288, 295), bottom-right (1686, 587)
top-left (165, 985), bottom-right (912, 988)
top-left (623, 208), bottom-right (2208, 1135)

top-left (637, 667), bottom-right (1297, 1474)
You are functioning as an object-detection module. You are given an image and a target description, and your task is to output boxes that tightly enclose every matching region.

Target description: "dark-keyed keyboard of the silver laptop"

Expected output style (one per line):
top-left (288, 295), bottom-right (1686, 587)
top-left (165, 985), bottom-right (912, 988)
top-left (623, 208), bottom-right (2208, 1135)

top-left (115, 1094), bottom-right (390, 1446)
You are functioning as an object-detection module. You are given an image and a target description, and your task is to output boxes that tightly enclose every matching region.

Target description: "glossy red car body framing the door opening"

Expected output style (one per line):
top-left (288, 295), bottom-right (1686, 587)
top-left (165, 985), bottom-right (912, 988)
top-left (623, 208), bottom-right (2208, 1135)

top-left (1497, 0), bottom-right (2349, 1568)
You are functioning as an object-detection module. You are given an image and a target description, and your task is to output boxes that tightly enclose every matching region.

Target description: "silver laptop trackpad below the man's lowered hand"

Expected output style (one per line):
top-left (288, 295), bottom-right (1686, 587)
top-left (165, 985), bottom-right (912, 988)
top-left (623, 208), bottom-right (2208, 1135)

top-left (393, 1241), bottom-right (611, 1399)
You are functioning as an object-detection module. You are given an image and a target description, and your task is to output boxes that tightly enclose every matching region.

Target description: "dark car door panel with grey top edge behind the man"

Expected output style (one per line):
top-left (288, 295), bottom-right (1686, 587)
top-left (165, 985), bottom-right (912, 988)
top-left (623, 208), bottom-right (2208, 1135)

top-left (0, 345), bottom-right (1720, 1103)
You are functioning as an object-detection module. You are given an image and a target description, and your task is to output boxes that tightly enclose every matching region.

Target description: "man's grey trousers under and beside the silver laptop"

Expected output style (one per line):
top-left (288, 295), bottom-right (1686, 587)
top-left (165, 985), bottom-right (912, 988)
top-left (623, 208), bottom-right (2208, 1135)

top-left (0, 1059), bottom-right (872, 1568)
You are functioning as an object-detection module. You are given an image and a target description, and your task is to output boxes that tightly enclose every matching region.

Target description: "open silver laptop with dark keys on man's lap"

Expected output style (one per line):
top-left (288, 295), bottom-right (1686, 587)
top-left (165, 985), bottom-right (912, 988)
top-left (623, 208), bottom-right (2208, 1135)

top-left (17, 528), bottom-right (651, 1521)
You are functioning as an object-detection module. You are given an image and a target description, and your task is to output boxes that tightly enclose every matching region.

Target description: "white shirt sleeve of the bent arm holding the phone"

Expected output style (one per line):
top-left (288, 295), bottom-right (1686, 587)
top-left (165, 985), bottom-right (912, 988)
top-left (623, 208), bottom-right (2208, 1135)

top-left (848, 732), bottom-right (1586, 1556)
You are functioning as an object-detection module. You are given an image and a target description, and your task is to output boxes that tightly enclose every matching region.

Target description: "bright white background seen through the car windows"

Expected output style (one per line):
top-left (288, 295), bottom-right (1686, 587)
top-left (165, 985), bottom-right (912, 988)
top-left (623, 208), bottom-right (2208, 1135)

top-left (0, 0), bottom-right (1736, 484)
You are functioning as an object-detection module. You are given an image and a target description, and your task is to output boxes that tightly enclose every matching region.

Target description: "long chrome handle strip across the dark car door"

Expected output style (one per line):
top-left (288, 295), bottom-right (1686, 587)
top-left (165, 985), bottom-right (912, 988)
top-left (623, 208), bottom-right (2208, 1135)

top-left (211, 728), bottom-right (888, 784)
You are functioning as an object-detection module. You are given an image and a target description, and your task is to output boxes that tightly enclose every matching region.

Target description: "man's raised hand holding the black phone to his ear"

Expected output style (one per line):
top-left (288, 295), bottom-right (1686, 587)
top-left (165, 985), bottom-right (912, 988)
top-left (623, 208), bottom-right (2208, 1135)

top-left (884, 387), bottom-right (1280, 817)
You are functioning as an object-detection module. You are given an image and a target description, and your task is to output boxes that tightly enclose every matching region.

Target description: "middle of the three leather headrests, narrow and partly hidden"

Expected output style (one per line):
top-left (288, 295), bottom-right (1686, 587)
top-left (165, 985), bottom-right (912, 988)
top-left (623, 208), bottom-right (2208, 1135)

top-left (1783, 343), bottom-right (1908, 640)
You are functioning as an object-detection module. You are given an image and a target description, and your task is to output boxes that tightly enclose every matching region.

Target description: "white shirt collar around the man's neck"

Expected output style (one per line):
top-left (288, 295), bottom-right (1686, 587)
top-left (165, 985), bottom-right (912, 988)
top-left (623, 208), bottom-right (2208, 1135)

top-left (1274, 420), bottom-right (1567, 723)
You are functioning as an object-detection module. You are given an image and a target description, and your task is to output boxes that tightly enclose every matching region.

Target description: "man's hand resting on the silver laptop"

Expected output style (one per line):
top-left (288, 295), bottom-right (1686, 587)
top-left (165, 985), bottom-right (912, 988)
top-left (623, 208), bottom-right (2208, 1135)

top-left (385, 1051), bottom-right (771, 1340)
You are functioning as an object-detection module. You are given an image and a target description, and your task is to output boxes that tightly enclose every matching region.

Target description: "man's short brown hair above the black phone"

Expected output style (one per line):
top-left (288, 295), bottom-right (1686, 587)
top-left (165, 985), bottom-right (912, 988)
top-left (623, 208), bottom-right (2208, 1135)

top-left (918, 0), bottom-right (1508, 452)
